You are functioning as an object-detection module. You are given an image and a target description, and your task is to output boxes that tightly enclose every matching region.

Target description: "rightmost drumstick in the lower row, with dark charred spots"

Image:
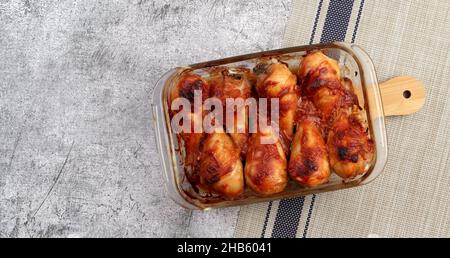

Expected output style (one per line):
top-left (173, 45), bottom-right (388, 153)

top-left (327, 111), bottom-right (374, 178)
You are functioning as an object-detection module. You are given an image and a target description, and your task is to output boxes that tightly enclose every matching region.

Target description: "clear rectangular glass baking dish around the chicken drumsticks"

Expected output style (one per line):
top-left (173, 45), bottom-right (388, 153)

top-left (151, 42), bottom-right (387, 209)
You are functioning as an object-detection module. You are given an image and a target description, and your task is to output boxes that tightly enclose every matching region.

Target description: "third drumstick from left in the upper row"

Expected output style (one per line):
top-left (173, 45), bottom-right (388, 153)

top-left (254, 60), bottom-right (298, 152)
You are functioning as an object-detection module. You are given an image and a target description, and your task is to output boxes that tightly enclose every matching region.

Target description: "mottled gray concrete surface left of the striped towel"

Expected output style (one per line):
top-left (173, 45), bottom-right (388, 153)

top-left (0, 0), bottom-right (290, 237)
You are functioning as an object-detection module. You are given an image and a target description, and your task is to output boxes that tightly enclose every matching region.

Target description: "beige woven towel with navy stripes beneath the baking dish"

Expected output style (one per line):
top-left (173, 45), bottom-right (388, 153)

top-left (235, 0), bottom-right (450, 237)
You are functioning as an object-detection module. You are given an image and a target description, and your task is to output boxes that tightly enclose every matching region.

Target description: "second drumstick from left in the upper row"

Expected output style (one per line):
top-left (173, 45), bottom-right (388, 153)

top-left (210, 68), bottom-right (252, 159)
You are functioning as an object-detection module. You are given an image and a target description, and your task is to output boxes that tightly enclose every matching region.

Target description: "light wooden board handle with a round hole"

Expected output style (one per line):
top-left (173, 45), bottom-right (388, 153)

top-left (380, 76), bottom-right (426, 116)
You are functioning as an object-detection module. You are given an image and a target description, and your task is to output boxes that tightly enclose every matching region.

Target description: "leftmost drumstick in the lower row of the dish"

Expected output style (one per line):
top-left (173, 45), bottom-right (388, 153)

top-left (200, 129), bottom-right (244, 199)
